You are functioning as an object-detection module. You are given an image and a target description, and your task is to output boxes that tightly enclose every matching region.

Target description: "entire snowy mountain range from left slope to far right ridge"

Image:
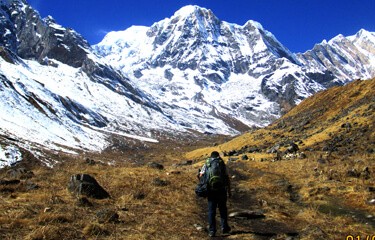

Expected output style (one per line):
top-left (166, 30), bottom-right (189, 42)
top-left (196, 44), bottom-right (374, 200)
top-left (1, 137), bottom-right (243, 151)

top-left (0, 0), bottom-right (375, 161)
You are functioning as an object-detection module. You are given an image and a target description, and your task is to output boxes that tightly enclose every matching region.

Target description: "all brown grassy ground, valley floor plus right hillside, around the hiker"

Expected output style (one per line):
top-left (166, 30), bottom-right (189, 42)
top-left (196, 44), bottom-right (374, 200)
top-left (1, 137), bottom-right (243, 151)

top-left (0, 80), bottom-right (375, 240)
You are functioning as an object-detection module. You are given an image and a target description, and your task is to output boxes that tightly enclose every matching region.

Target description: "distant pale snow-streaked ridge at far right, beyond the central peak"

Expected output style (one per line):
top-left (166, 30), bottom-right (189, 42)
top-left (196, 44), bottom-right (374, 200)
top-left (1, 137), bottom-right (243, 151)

top-left (298, 29), bottom-right (375, 86)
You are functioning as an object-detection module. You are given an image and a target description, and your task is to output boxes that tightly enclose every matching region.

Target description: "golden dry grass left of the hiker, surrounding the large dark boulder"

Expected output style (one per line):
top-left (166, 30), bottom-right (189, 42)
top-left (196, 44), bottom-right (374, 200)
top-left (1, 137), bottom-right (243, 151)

top-left (0, 158), bottom-right (207, 239)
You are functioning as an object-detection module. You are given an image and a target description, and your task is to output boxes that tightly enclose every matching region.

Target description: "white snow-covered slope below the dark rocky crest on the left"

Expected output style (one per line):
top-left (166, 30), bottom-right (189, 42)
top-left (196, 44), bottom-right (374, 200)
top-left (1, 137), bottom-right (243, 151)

top-left (0, 58), bottom-right (164, 150)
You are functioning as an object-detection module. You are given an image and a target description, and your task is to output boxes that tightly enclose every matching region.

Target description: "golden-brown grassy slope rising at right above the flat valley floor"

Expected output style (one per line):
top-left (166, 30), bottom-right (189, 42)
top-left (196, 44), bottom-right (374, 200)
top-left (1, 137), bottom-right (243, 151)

top-left (188, 79), bottom-right (375, 158)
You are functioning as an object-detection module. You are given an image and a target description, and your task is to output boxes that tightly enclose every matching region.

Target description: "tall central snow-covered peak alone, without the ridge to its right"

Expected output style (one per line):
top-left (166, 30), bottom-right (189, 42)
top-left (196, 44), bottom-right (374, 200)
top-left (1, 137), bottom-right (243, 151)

top-left (94, 6), bottom-right (306, 131)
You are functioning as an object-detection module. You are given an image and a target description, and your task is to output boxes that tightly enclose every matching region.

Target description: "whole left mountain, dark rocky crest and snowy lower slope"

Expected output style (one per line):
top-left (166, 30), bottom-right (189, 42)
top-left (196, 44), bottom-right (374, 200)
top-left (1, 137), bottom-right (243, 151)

top-left (0, 0), bottom-right (183, 156)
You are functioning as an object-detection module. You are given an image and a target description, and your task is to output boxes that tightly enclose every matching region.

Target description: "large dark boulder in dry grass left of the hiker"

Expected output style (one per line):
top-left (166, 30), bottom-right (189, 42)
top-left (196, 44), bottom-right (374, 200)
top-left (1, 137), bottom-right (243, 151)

top-left (68, 174), bottom-right (110, 199)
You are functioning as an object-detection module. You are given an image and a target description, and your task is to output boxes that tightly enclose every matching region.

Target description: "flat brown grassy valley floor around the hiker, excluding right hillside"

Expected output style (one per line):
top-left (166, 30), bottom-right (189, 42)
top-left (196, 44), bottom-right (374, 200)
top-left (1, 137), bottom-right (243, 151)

top-left (0, 134), bottom-right (375, 239)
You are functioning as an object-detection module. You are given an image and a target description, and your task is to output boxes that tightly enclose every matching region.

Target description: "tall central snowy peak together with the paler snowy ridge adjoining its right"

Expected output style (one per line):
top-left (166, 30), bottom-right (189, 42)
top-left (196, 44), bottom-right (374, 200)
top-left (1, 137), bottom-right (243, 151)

top-left (94, 6), bottom-right (375, 132)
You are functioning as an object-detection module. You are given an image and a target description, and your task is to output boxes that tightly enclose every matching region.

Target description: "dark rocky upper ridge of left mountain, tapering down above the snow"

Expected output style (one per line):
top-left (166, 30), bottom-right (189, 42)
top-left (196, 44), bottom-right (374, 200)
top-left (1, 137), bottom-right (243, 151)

top-left (0, 0), bottom-right (157, 109)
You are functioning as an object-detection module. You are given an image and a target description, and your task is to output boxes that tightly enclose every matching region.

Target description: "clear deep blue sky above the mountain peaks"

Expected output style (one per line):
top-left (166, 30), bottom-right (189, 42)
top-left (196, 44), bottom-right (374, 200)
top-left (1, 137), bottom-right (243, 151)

top-left (28, 0), bottom-right (375, 52)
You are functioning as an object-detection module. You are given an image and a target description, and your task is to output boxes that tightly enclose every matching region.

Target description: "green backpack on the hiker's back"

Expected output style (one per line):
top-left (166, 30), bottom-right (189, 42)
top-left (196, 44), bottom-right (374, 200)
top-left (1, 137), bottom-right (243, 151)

top-left (206, 158), bottom-right (226, 192)
